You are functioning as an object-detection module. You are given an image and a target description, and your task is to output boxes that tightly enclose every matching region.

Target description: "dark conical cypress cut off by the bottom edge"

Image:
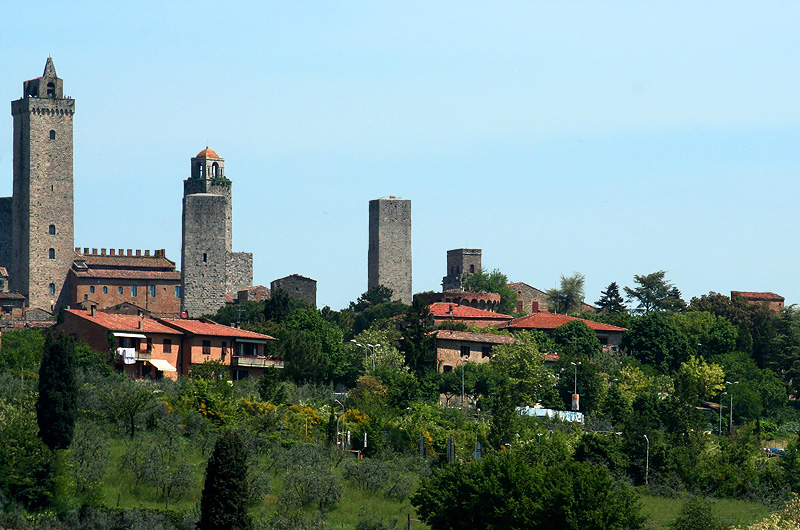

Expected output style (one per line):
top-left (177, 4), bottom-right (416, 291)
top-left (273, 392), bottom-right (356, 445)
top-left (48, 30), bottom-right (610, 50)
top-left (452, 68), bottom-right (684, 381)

top-left (197, 431), bottom-right (250, 530)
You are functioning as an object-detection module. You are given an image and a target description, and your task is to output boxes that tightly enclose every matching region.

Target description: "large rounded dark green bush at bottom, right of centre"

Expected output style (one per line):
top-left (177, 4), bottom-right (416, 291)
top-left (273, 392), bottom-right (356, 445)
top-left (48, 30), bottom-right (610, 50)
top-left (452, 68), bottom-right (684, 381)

top-left (411, 453), bottom-right (644, 530)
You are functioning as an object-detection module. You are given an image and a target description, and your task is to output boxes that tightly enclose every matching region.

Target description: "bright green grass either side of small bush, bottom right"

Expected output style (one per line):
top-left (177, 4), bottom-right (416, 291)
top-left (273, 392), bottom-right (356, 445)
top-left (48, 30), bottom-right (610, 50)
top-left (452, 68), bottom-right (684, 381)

top-left (640, 495), bottom-right (770, 529)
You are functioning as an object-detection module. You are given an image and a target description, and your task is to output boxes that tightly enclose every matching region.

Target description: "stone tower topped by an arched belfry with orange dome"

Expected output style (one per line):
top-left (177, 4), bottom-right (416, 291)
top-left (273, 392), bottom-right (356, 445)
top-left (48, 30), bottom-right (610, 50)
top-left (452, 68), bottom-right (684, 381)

top-left (181, 147), bottom-right (253, 317)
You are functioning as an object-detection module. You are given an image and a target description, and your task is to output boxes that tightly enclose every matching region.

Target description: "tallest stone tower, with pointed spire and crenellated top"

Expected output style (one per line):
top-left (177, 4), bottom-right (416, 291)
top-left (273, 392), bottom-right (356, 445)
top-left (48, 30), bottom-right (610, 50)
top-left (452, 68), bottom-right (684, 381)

top-left (11, 57), bottom-right (75, 311)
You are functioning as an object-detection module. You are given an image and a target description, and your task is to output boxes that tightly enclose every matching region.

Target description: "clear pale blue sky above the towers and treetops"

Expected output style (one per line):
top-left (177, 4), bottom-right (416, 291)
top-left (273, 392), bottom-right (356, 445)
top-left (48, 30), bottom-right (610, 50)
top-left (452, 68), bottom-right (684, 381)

top-left (0, 0), bottom-right (800, 309)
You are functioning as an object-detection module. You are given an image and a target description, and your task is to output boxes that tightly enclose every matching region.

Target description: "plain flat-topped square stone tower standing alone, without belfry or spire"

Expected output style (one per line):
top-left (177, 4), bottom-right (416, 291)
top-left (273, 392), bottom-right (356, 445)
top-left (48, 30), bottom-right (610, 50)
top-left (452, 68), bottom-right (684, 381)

top-left (367, 196), bottom-right (412, 304)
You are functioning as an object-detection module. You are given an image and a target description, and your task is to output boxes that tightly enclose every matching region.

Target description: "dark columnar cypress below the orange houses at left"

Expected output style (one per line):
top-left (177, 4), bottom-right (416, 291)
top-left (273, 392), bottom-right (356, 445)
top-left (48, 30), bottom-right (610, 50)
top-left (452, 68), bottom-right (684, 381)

top-left (36, 333), bottom-right (78, 451)
